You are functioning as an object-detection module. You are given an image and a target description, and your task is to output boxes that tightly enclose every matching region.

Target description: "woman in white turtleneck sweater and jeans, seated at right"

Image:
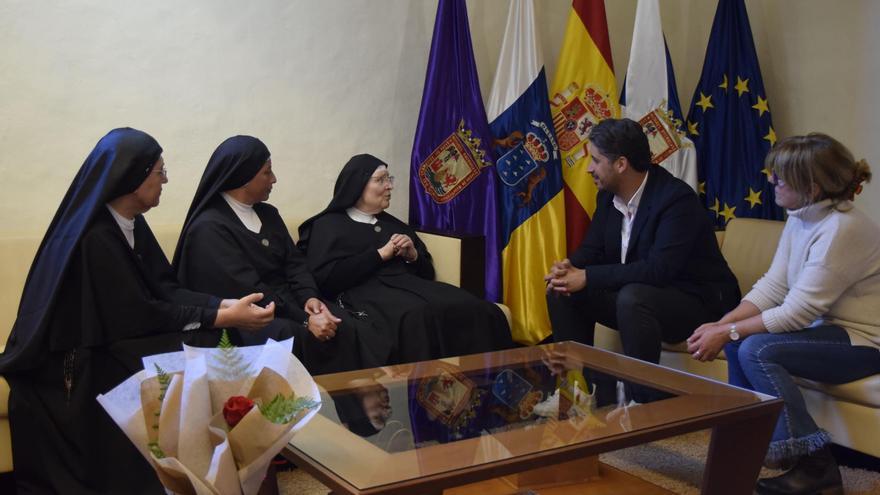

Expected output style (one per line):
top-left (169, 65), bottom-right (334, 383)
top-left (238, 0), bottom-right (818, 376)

top-left (688, 133), bottom-right (880, 493)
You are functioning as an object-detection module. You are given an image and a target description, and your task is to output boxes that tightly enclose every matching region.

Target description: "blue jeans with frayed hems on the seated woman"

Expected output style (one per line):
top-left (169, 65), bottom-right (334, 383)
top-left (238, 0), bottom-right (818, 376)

top-left (724, 325), bottom-right (880, 461)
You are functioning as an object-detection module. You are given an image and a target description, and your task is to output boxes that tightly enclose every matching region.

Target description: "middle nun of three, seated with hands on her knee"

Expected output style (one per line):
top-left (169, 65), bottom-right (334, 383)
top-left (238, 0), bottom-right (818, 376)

top-left (174, 136), bottom-right (392, 374)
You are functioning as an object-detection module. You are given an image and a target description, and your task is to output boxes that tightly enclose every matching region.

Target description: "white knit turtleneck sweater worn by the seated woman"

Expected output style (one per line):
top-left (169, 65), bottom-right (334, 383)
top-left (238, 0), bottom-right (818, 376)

top-left (744, 200), bottom-right (880, 347)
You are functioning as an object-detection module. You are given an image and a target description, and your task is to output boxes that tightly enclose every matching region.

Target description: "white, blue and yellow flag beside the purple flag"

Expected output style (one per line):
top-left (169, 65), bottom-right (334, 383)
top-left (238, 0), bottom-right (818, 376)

top-left (486, 0), bottom-right (565, 344)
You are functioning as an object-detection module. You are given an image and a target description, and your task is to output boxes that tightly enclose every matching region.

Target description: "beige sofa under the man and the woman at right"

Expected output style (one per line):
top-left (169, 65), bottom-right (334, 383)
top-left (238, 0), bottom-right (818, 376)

top-left (596, 218), bottom-right (880, 457)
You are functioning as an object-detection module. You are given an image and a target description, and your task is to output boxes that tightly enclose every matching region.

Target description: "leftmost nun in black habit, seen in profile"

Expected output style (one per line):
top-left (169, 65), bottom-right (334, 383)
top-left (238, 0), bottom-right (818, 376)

top-left (0, 128), bottom-right (273, 494)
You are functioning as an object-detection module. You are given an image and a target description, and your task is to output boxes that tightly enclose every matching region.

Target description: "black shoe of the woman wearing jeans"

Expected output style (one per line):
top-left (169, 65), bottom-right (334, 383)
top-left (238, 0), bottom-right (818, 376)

top-left (755, 445), bottom-right (843, 495)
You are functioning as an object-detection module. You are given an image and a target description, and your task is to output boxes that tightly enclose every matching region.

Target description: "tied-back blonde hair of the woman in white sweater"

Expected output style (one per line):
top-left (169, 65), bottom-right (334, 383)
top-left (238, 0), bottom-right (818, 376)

top-left (764, 132), bottom-right (871, 206)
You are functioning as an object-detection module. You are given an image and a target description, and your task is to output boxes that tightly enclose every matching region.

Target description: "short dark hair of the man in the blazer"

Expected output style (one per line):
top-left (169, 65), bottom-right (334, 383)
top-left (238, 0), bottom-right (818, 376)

top-left (590, 119), bottom-right (651, 172)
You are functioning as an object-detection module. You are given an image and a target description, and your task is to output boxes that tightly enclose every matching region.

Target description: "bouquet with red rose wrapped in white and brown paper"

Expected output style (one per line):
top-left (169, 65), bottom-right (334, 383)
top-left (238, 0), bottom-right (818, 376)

top-left (98, 334), bottom-right (321, 495)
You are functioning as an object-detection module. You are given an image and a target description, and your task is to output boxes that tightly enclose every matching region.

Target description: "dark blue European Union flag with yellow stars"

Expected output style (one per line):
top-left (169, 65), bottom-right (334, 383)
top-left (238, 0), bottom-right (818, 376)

top-left (687, 0), bottom-right (782, 228)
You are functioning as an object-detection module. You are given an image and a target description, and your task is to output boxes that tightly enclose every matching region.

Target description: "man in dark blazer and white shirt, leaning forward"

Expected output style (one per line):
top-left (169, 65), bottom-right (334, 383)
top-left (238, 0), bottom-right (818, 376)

top-left (545, 119), bottom-right (740, 402)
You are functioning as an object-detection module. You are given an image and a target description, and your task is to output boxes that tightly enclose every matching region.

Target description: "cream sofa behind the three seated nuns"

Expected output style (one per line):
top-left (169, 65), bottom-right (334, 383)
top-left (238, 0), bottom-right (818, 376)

top-left (0, 220), bottom-right (482, 473)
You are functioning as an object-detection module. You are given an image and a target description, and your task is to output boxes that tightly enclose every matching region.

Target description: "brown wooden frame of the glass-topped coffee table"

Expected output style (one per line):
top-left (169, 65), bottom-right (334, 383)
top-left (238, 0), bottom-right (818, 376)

top-left (283, 342), bottom-right (782, 495)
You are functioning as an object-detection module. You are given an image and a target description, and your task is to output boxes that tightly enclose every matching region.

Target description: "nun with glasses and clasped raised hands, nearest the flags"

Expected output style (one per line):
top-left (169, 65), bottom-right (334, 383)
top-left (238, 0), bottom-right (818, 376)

top-left (299, 154), bottom-right (513, 362)
